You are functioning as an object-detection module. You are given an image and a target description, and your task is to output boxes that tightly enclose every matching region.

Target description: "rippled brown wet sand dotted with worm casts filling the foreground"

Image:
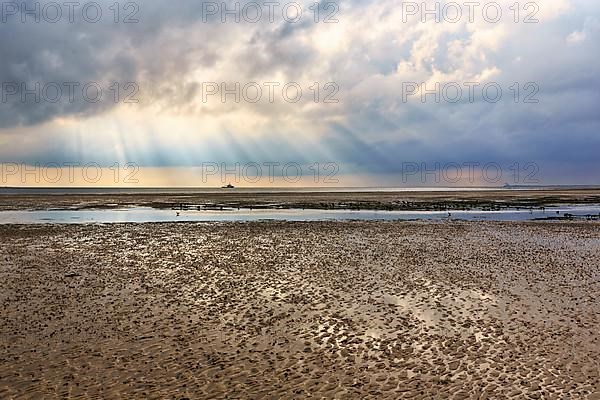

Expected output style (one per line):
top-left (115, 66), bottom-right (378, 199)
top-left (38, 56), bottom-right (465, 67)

top-left (0, 222), bottom-right (600, 400)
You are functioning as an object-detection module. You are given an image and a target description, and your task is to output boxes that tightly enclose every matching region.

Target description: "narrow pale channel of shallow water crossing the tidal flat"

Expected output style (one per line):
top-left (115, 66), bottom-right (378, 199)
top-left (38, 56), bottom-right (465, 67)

top-left (0, 206), bottom-right (600, 224)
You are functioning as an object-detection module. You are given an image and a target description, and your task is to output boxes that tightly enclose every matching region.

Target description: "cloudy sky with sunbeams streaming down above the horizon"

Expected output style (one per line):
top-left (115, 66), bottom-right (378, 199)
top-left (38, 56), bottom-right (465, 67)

top-left (0, 0), bottom-right (600, 186)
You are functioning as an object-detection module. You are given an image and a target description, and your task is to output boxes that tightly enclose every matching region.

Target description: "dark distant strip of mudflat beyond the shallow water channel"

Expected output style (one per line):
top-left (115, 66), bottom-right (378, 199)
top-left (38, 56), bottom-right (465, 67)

top-left (0, 189), bottom-right (600, 211)
